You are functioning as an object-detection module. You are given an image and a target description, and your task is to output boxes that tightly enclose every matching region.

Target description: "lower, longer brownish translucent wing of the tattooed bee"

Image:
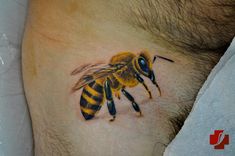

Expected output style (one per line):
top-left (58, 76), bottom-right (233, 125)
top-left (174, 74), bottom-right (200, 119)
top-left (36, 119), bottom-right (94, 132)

top-left (72, 62), bottom-right (127, 92)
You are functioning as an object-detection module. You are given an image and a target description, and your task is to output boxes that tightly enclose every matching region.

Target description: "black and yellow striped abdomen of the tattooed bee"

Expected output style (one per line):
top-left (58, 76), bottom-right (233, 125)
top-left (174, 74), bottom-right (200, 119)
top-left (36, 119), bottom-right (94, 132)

top-left (80, 80), bottom-right (104, 120)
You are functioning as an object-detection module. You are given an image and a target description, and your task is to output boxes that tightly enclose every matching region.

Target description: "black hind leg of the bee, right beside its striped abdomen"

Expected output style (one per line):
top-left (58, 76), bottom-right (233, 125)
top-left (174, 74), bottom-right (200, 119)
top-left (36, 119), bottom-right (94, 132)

top-left (104, 79), bottom-right (116, 121)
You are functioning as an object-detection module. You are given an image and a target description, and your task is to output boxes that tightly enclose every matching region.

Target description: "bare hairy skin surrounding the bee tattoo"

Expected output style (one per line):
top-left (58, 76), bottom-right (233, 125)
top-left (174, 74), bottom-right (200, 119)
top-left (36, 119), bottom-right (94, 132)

top-left (23, 0), bottom-right (234, 156)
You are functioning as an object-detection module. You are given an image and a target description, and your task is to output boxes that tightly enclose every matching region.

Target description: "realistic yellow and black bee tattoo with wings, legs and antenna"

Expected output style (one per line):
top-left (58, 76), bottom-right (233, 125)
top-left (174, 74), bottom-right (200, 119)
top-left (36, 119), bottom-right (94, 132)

top-left (71, 51), bottom-right (174, 121)
